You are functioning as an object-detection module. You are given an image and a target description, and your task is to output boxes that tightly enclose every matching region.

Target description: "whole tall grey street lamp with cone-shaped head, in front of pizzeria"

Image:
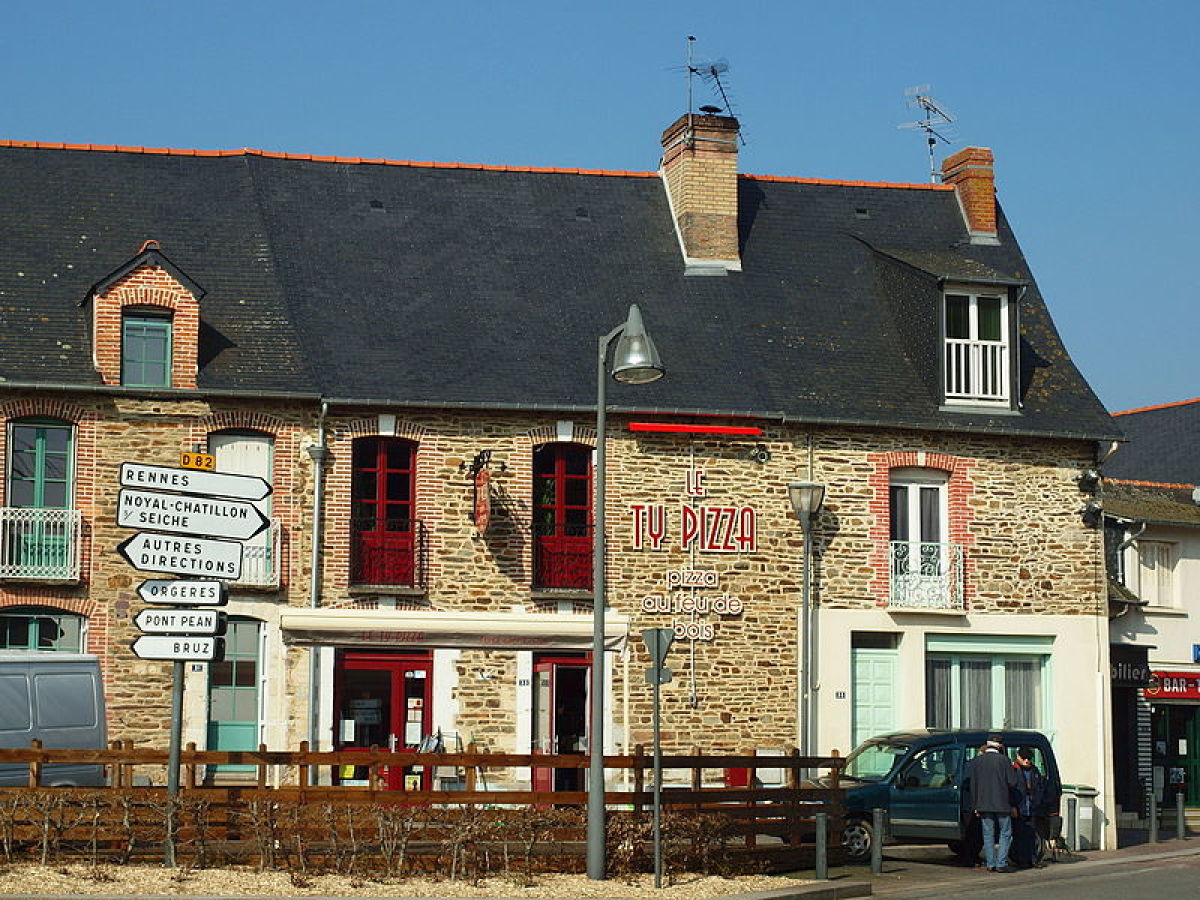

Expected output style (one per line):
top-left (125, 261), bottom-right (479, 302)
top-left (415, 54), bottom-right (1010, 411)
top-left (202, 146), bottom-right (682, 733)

top-left (588, 304), bottom-right (666, 881)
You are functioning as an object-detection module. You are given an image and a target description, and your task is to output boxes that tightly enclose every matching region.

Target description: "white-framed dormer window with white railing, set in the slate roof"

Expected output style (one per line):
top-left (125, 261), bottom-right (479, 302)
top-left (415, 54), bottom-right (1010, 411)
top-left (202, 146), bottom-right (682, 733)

top-left (943, 290), bottom-right (1012, 404)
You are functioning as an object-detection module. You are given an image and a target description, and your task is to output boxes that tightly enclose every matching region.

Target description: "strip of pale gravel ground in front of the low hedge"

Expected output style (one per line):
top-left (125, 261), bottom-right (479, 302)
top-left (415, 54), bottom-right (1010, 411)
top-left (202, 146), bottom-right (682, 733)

top-left (0, 864), bottom-right (805, 900)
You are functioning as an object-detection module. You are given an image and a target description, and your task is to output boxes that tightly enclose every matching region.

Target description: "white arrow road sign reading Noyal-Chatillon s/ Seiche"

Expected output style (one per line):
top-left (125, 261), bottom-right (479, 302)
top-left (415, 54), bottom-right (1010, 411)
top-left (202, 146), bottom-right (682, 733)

top-left (116, 490), bottom-right (270, 541)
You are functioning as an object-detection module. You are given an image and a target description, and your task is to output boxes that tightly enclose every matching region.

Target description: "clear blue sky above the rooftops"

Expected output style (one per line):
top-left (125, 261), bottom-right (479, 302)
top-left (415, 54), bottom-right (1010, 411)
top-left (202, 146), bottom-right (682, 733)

top-left (0, 0), bottom-right (1200, 410)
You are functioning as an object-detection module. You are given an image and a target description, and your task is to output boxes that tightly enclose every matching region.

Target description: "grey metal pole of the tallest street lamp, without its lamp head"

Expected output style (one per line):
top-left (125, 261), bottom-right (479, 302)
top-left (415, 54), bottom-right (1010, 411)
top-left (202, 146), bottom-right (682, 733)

top-left (587, 325), bottom-right (625, 881)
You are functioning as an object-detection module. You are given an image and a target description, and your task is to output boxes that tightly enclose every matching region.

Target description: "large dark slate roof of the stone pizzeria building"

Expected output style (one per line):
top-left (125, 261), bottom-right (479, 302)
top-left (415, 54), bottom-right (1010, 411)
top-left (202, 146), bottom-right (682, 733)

top-left (0, 145), bottom-right (1120, 438)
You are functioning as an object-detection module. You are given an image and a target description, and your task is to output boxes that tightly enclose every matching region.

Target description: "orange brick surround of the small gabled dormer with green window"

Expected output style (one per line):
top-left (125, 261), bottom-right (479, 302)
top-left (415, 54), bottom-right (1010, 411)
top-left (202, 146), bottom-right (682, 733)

top-left (91, 241), bottom-right (204, 388)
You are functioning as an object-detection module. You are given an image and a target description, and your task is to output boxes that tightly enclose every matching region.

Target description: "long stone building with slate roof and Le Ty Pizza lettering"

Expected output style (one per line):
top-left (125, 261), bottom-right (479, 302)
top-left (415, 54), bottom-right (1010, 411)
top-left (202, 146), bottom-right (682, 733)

top-left (0, 115), bottom-right (1120, 844)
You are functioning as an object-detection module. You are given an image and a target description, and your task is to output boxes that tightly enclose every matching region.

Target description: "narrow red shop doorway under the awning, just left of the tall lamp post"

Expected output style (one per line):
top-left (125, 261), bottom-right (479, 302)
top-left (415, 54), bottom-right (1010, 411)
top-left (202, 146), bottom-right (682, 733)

top-left (533, 654), bottom-right (592, 791)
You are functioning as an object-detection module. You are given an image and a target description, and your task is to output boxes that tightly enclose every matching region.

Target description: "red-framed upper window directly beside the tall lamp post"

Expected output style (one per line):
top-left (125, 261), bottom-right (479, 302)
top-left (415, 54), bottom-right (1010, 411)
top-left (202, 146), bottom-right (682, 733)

top-left (533, 443), bottom-right (592, 590)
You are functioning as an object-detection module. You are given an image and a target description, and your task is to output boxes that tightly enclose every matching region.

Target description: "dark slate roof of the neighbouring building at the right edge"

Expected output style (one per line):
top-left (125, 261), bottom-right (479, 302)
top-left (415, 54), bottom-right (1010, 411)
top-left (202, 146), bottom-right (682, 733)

top-left (1104, 398), bottom-right (1200, 485)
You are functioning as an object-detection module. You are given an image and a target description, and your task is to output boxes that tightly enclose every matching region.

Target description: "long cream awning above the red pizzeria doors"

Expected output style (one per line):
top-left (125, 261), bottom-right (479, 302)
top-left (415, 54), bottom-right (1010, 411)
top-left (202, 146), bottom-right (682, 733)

top-left (280, 608), bottom-right (629, 650)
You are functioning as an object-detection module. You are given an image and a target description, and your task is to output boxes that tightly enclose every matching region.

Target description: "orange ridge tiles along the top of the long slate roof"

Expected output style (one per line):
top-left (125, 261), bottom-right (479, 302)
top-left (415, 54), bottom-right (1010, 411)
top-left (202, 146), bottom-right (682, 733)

top-left (0, 140), bottom-right (955, 188)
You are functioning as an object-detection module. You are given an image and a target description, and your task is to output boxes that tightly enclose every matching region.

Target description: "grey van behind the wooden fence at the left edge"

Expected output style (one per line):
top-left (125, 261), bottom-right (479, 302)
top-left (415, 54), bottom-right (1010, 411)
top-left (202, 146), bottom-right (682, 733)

top-left (0, 650), bottom-right (107, 787)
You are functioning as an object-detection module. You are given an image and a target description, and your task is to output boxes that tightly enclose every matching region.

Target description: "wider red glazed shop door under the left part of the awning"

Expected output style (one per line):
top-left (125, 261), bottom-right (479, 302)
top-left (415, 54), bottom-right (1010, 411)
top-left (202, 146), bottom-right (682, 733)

top-left (334, 650), bottom-right (433, 791)
